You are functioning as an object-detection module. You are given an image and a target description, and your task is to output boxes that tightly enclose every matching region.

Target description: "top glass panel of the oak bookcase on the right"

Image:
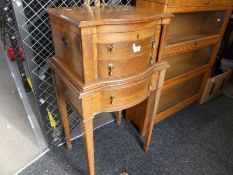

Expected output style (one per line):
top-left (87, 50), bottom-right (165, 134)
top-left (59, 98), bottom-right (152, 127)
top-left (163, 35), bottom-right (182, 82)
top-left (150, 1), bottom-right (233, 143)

top-left (167, 11), bottom-right (227, 45)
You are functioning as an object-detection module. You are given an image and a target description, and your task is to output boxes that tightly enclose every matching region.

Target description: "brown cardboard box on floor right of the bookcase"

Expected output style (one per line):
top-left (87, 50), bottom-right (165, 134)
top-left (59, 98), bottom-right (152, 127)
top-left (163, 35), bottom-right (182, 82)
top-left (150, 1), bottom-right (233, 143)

top-left (200, 67), bottom-right (231, 104)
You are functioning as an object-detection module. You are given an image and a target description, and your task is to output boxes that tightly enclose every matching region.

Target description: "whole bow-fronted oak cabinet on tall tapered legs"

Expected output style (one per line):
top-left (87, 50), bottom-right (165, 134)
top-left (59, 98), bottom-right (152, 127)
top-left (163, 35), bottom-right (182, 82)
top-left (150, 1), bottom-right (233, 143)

top-left (47, 6), bottom-right (172, 175)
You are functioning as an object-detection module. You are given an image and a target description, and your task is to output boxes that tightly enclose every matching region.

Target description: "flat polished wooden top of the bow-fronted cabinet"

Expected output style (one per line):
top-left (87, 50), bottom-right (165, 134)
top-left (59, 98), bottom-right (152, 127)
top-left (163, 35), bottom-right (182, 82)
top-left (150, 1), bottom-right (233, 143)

top-left (47, 6), bottom-right (173, 27)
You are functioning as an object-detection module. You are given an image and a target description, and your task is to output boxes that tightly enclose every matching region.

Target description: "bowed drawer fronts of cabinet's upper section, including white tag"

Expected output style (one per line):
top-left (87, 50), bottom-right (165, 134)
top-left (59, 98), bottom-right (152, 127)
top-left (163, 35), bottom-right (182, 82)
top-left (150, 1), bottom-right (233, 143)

top-left (97, 26), bottom-right (161, 78)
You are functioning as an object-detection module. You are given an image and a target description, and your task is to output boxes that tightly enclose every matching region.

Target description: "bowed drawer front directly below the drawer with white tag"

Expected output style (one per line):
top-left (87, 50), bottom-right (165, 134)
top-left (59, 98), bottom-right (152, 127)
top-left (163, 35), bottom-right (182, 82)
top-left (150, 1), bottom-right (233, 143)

top-left (98, 52), bottom-right (155, 78)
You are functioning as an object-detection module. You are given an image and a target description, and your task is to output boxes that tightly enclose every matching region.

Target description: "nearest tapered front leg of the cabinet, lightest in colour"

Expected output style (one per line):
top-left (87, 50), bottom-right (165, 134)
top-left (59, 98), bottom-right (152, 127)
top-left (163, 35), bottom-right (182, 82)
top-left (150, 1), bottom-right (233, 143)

top-left (83, 119), bottom-right (95, 175)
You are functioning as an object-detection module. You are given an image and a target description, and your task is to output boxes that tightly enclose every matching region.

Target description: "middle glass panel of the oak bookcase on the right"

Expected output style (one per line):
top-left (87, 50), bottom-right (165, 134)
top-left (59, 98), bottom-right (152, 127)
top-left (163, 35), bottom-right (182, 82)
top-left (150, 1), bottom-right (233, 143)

top-left (162, 46), bottom-right (213, 80)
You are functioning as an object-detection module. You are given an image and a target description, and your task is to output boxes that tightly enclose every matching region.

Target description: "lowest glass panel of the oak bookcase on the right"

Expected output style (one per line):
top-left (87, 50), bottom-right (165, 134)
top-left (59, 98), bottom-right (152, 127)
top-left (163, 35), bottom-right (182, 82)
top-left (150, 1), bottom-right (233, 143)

top-left (158, 74), bottom-right (204, 113)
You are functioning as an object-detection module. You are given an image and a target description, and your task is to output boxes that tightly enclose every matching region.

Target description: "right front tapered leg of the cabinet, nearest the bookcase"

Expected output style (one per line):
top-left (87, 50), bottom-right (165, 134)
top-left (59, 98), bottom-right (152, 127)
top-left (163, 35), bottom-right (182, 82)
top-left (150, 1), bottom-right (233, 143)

top-left (143, 90), bottom-right (161, 151)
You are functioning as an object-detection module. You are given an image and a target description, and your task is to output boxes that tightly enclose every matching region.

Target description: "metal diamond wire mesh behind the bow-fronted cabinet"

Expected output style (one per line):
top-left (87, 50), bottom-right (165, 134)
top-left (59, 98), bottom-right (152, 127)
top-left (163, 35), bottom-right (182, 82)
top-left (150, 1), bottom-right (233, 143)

top-left (7, 0), bottom-right (134, 145)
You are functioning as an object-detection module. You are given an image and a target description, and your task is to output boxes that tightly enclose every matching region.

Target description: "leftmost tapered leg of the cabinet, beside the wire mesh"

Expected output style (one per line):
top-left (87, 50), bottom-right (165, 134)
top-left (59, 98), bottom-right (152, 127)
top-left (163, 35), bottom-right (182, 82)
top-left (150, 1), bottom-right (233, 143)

top-left (55, 76), bottom-right (72, 151)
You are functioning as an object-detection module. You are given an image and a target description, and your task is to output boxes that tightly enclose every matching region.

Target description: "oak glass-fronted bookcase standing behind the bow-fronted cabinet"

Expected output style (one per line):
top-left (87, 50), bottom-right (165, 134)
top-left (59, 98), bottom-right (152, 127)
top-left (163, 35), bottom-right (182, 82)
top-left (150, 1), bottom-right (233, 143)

top-left (129, 0), bottom-right (233, 135)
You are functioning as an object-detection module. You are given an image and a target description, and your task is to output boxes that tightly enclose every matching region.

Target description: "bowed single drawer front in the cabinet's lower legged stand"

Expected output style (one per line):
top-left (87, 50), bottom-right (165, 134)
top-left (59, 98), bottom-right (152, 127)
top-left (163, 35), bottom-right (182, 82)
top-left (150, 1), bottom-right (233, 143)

top-left (100, 73), bottom-right (158, 111)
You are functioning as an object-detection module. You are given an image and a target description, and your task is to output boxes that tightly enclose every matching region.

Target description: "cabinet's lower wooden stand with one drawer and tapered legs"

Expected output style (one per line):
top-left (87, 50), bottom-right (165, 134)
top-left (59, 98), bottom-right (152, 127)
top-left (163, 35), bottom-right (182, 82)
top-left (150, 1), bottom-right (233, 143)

top-left (49, 58), bottom-right (168, 174)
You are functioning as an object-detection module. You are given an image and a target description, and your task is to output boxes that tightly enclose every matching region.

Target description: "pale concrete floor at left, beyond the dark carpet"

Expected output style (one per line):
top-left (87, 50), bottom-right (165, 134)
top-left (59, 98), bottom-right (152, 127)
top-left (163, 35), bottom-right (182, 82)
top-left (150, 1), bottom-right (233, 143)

top-left (0, 48), bottom-right (44, 175)
